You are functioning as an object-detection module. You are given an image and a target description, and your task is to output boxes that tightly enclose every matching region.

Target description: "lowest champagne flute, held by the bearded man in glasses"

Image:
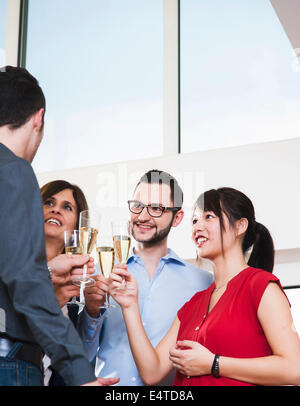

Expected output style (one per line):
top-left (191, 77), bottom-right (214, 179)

top-left (96, 236), bottom-right (116, 309)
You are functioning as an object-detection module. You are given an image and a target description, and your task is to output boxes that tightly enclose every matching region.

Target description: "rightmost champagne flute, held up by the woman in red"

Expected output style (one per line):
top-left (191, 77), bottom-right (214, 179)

top-left (112, 220), bottom-right (131, 290)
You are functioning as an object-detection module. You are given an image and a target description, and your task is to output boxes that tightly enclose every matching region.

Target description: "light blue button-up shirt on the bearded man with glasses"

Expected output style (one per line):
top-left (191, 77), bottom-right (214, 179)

top-left (78, 249), bottom-right (213, 386)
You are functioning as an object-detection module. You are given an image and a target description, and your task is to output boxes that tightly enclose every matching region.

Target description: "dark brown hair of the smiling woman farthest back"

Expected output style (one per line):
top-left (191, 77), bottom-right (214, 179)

top-left (40, 180), bottom-right (89, 228)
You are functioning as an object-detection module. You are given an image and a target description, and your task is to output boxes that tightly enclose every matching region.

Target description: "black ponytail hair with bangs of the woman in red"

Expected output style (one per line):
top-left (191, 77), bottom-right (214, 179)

top-left (195, 187), bottom-right (274, 272)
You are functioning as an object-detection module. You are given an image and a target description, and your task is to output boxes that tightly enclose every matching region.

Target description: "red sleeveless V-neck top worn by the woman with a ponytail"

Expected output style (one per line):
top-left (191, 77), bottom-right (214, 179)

top-left (174, 267), bottom-right (283, 386)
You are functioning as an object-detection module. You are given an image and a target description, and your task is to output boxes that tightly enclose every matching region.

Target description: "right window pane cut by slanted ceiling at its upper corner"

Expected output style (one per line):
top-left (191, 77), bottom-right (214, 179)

top-left (181, 0), bottom-right (300, 152)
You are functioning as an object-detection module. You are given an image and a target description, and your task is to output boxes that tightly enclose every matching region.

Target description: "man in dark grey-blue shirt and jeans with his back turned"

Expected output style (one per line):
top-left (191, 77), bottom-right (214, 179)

top-left (0, 66), bottom-right (118, 386)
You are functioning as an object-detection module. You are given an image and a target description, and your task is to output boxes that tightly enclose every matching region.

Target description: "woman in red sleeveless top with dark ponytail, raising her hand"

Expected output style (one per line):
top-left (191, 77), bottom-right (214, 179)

top-left (111, 188), bottom-right (300, 386)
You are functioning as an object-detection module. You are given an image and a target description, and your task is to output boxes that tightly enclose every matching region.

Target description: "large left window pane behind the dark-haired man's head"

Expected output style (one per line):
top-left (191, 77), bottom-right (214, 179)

top-left (26, 0), bottom-right (163, 171)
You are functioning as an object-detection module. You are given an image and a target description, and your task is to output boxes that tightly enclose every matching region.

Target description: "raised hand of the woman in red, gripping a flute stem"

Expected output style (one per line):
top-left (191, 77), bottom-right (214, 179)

top-left (109, 264), bottom-right (138, 308)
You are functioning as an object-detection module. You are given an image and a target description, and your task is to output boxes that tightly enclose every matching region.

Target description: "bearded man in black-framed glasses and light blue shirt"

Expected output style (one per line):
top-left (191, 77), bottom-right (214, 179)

top-left (79, 170), bottom-right (212, 386)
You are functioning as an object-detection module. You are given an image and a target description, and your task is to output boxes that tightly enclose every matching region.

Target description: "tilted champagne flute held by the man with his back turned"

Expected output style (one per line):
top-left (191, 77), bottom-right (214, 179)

top-left (73, 210), bottom-right (100, 287)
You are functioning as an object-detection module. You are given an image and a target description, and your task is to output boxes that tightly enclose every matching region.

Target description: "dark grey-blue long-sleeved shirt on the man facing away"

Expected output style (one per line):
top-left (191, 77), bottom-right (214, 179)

top-left (0, 143), bottom-right (95, 385)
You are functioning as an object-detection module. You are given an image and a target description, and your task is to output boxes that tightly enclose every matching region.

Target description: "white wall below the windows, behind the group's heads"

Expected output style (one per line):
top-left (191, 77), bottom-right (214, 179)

top-left (37, 138), bottom-right (300, 284)
